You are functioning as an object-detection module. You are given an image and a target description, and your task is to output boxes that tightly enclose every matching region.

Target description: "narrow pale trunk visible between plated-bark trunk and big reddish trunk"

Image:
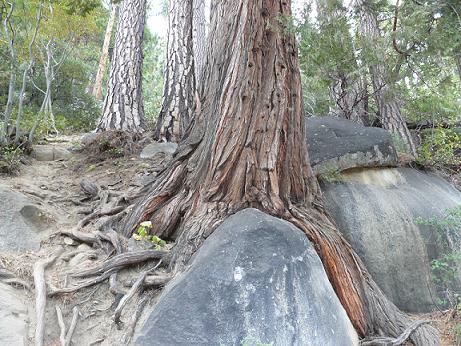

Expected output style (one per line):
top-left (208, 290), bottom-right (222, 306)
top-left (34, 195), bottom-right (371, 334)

top-left (192, 0), bottom-right (206, 85)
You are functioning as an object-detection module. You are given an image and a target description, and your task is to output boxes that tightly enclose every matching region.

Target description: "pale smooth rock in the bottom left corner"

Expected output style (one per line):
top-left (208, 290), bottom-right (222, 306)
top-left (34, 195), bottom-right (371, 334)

top-left (0, 283), bottom-right (29, 346)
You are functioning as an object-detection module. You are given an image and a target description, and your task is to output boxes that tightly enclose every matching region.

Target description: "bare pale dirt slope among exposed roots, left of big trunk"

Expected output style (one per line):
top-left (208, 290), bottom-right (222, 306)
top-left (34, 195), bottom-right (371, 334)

top-left (0, 137), bottom-right (166, 345)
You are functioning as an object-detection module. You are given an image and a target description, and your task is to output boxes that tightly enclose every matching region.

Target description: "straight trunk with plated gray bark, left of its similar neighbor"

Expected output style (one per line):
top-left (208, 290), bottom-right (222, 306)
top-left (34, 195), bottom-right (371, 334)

top-left (98, 0), bottom-right (147, 133)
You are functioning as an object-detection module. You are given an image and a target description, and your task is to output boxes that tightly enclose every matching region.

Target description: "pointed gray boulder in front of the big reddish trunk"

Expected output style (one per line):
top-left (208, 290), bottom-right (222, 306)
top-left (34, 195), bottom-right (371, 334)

top-left (136, 209), bottom-right (358, 346)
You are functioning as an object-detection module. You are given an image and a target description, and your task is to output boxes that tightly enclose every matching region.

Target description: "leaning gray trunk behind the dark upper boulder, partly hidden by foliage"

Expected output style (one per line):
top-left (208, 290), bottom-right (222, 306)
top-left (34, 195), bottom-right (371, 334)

top-left (356, 0), bottom-right (416, 156)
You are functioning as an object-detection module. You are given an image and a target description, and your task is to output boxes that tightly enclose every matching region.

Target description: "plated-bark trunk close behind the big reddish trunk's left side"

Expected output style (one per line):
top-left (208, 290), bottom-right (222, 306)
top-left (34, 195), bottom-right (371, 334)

top-left (156, 0), bottom-right (195, 141)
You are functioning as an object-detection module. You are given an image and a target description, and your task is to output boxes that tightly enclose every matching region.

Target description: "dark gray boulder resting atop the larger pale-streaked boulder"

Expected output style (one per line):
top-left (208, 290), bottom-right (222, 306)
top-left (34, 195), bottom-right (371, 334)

top-left (306, 117), bottom-right (398, 172)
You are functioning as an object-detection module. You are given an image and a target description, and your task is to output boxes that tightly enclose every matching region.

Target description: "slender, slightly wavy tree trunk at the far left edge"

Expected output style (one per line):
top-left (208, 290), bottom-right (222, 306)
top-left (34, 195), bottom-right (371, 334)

top-left (0, 1), bottom-right (16, 144)
